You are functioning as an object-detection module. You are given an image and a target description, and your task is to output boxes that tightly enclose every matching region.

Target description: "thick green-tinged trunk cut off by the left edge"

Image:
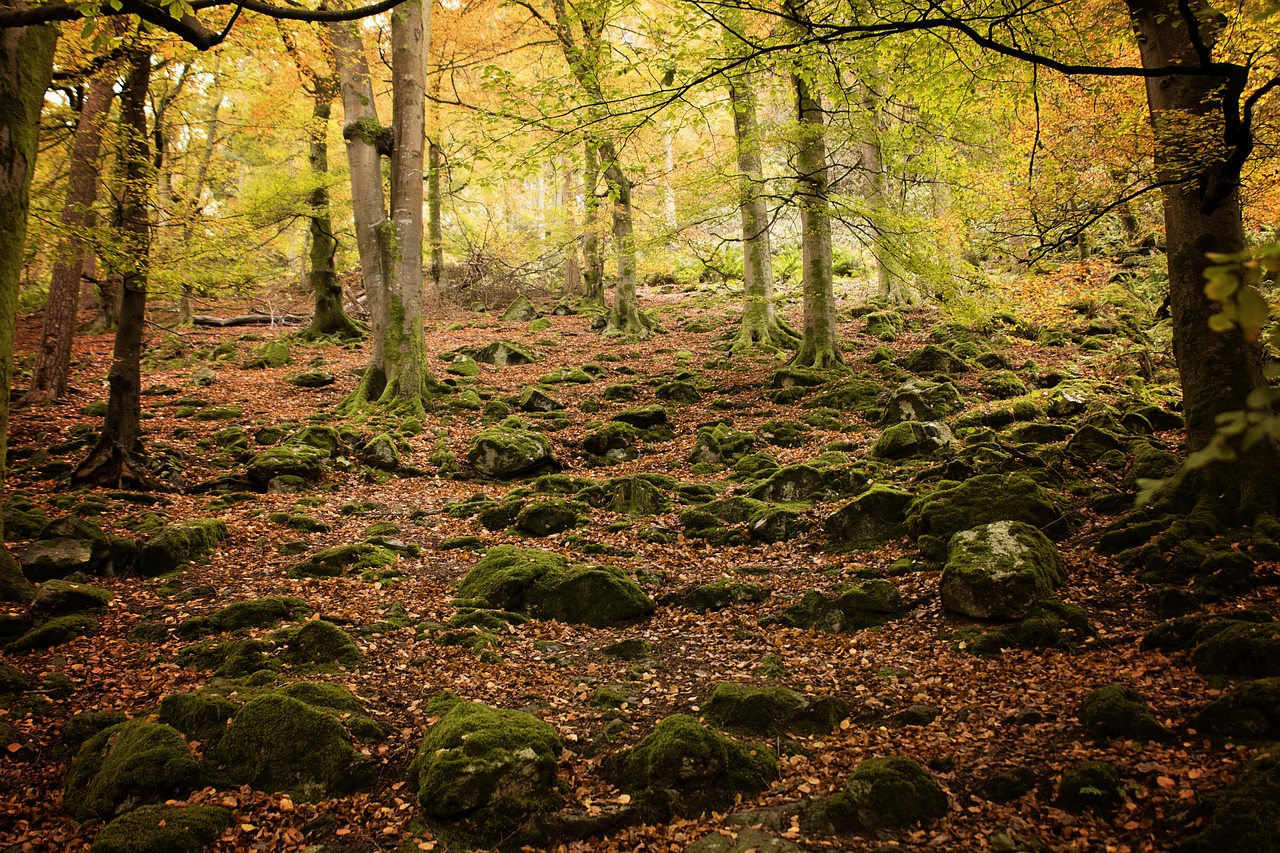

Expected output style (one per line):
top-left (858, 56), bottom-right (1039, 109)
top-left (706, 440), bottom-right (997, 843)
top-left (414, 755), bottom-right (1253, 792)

top-left (0, 13), bottom-right (58, 555)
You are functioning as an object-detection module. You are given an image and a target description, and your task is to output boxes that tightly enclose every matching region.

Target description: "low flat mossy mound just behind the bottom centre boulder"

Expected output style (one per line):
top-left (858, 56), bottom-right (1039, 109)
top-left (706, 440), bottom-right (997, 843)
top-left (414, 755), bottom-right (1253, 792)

top-left (703, 683), bottom-right (849, 735)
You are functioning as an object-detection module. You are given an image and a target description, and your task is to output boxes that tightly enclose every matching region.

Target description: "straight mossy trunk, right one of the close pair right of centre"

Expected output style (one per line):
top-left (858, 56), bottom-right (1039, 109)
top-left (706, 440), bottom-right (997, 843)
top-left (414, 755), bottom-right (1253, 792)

top-left (791, 74), bottom-right (845, 370)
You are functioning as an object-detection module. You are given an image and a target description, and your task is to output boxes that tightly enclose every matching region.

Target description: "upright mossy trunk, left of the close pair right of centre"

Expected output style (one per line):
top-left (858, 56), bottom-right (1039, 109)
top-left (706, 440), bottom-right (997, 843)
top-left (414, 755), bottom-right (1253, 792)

top-left (724, 28), bottom-right (800, 352)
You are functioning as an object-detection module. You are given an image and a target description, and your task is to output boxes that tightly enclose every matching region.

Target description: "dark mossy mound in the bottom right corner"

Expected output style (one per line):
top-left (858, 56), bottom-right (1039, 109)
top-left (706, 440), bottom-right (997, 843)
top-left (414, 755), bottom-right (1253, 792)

top-left (1183, 749), bottom-right (1280, 853)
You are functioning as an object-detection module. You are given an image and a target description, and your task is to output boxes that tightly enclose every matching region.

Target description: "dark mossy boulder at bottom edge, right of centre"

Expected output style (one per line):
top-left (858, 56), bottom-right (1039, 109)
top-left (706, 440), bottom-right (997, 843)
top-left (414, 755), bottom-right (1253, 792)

top-left (801, 756), bottom-right (947, 835)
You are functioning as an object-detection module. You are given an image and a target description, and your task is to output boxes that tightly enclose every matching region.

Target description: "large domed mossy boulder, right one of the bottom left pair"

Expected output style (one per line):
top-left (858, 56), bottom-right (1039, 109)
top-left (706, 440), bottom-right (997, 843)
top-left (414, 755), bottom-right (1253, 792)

top-left (206, 693), bottom-right (372, 800)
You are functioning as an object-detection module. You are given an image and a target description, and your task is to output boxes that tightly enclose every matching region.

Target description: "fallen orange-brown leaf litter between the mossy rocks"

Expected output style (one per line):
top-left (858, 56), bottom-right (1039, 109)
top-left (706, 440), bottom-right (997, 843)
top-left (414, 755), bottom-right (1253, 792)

top-left (0, 267), bottom-right (1280, 852)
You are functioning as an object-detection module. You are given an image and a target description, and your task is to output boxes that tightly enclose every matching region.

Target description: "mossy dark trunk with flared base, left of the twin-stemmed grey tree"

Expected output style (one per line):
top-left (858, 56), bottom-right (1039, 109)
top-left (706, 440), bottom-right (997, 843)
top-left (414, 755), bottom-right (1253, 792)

top-left (305, 86), bottom-right (362, 338)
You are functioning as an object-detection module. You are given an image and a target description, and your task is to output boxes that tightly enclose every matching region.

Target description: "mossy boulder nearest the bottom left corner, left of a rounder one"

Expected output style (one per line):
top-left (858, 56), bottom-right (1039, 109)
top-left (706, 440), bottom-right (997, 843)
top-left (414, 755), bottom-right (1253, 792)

top-left (63, 720), bottom-right (200, 822)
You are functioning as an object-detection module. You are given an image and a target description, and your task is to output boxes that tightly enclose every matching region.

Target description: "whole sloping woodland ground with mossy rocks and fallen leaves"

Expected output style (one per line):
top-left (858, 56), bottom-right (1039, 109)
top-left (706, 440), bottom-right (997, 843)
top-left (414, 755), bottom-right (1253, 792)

top-left (0, 274), bottom-right (1280, 850)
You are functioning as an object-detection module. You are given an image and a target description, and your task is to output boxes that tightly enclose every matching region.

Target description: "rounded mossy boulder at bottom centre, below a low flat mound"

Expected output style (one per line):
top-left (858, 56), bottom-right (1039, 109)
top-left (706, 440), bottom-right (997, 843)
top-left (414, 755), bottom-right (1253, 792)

top-left (612, 713), bottom-right (777, 820)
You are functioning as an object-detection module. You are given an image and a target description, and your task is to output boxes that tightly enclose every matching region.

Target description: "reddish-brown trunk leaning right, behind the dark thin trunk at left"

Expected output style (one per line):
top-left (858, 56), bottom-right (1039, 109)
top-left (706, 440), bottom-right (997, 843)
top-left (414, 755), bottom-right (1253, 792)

top-left (15, 66), bottom-right (115, 406)
